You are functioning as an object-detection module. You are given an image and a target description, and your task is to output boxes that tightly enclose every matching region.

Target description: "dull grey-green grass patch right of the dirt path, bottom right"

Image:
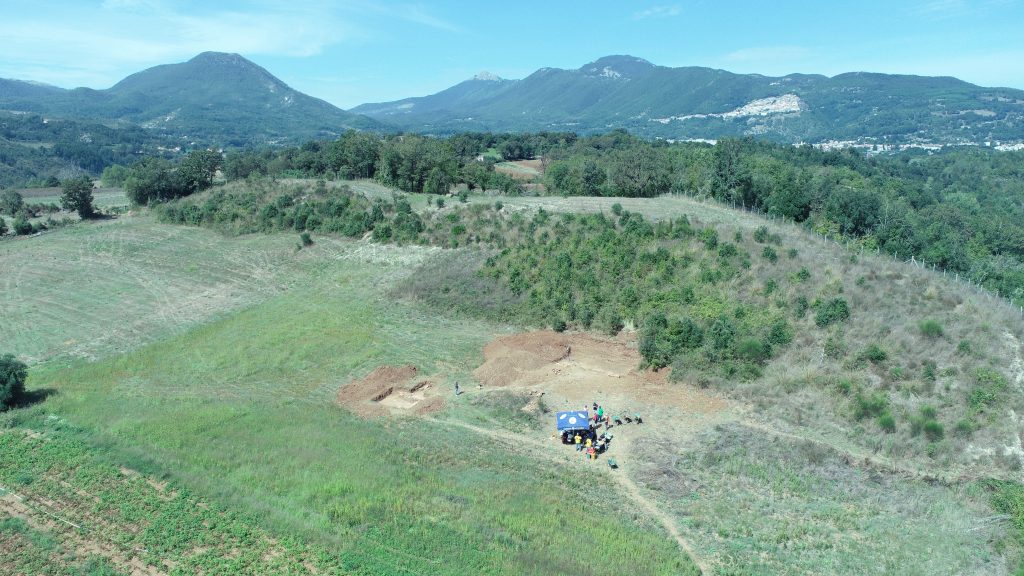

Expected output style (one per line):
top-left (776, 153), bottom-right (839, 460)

top-left (640, 426), bottom-right (1002, 575)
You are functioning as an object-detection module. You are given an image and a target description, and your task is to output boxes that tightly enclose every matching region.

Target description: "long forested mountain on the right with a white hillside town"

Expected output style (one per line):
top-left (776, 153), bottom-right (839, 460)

top-left (352, 55), bottom-right (1024, 143)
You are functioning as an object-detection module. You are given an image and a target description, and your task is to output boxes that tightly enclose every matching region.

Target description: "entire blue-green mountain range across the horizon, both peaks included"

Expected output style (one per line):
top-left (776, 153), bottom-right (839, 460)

top-left (0, 52), bottom-right (1024, 147)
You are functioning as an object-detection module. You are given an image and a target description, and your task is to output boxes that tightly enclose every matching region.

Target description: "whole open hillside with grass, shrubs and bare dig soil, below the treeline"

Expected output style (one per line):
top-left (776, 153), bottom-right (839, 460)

top-left (0, 180), bottom-right (1024, 575)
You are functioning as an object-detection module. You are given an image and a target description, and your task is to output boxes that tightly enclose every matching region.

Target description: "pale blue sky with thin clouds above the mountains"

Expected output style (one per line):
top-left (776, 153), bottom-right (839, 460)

top-left (0, 0), bottom-right (1024, 108)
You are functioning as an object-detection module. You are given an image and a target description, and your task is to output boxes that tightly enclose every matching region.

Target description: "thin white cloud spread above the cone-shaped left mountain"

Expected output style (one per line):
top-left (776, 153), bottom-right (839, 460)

top-left (0, 0), bottom-right (368, 87)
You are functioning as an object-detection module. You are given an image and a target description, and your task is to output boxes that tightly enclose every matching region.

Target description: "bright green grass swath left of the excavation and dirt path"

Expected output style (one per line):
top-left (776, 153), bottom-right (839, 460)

top-left (5, 216), bottom-right (692, 574)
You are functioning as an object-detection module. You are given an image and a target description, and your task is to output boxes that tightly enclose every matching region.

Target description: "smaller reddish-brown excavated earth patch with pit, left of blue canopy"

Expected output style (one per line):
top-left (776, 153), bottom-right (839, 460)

top-left (338, 366), bottom-right (444, 417)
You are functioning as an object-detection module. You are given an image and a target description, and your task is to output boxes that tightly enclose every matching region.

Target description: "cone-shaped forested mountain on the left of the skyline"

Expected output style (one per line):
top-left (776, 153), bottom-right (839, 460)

top-left (0, 52), bottom-right (380, 147)
